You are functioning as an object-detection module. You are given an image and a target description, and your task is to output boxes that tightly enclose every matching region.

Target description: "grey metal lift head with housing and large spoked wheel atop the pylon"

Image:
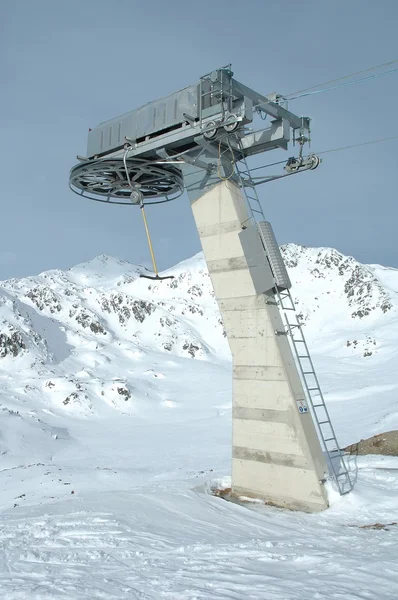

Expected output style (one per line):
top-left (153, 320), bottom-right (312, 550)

top-left (70, 65), bottom-right (316, 204)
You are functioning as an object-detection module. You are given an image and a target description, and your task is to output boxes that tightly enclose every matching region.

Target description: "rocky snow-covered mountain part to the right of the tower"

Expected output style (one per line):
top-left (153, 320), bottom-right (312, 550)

top-left (282, 244), bottom-right (398, 357)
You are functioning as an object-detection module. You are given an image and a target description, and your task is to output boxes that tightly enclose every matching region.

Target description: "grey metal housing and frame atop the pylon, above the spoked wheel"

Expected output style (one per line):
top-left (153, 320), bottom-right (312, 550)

top-left (87, 68), bottom-right (310, 160)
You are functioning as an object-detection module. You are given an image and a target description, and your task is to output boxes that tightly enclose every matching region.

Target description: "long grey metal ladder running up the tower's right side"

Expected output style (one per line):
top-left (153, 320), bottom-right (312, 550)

top-left (235, 138), bottom-right (353, 495)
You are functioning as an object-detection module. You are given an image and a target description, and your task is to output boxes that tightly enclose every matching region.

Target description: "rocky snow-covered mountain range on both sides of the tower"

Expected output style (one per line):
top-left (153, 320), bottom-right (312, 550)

top-left (0, 244), bottom-right (398, 418)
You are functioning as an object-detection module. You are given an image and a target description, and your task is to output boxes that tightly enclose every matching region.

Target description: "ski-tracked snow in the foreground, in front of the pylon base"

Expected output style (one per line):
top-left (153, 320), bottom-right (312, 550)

top-left (0, 492), bottom-right (398, 600)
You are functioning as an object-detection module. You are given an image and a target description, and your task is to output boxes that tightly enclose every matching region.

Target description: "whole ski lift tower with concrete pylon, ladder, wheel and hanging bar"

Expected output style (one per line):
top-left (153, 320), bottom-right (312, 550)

top-left (70, 65), bottom-right (352, 512)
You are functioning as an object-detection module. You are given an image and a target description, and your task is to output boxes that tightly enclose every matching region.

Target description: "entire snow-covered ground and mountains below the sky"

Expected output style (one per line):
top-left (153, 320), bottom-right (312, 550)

top-left (0, 245), bottom-right (398, 600)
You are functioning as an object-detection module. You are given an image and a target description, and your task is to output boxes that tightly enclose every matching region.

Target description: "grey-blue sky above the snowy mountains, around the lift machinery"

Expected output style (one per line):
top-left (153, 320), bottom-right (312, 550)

top-left (0, 0), bottom-right (398, 279)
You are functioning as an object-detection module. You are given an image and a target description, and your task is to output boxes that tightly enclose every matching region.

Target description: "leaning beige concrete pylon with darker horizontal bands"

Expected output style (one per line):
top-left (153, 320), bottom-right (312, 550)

top-left (191, 181), bottom-right (328, 512)
